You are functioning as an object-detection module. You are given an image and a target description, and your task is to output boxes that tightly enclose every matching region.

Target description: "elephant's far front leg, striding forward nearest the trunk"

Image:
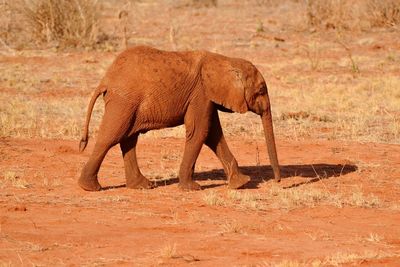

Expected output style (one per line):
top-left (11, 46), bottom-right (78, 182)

top-left (205, 110), bottom-right (250, 189)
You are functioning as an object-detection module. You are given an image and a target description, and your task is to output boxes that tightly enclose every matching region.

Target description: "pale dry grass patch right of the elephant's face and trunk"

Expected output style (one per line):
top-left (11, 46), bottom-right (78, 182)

top-left (272, 77), bottom-right (400, 143)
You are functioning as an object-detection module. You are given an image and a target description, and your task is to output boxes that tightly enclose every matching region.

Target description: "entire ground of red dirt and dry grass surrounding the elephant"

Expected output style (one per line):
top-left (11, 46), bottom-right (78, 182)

top-left (0, 1), bottom-right (400, 266)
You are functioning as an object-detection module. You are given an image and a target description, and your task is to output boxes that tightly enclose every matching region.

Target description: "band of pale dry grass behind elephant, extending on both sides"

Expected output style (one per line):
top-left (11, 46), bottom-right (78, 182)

top-left (0, 64), bottom-right (400, 143)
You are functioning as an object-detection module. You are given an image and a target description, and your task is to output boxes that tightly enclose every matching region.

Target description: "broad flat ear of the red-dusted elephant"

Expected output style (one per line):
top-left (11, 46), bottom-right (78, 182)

top-left (201, 54), bottom-right (248, 113)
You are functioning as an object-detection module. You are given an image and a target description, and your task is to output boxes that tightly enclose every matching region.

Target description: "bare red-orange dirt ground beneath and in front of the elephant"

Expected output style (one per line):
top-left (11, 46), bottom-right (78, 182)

top-left (0, 138), bottom-right (400, 266)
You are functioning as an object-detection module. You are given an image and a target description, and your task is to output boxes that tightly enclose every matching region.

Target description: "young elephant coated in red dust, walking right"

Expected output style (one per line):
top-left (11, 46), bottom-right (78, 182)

top-left (78, 46), bottom-right (281, 191)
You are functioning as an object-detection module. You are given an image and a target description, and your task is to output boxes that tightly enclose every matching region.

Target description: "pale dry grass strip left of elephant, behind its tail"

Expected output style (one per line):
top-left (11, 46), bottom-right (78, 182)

top-left (0, 93), bottom-right (103, 138)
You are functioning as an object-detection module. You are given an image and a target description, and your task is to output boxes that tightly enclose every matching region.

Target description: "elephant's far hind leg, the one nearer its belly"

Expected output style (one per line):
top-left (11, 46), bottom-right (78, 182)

top-left (120, 134), bottom-right (154, 189)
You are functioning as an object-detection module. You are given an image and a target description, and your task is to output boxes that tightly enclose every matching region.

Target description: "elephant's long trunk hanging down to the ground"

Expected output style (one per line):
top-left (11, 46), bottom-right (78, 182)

top-left (261, 109), bottom-right (281, 182)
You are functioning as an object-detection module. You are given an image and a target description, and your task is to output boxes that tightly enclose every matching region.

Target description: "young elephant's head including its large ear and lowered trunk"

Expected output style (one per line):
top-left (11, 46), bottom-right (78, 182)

top-left (201, 53), bottom-right (281, 182)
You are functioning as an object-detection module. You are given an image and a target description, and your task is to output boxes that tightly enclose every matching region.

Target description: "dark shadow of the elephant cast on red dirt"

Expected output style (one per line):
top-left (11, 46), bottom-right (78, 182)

top-left (103, 163), bottom-right (358, 190)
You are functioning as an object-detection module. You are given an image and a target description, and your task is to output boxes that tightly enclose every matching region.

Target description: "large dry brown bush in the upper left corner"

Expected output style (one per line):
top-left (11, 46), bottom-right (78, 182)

top-left (4, 0), bottom-right (98, 47)
